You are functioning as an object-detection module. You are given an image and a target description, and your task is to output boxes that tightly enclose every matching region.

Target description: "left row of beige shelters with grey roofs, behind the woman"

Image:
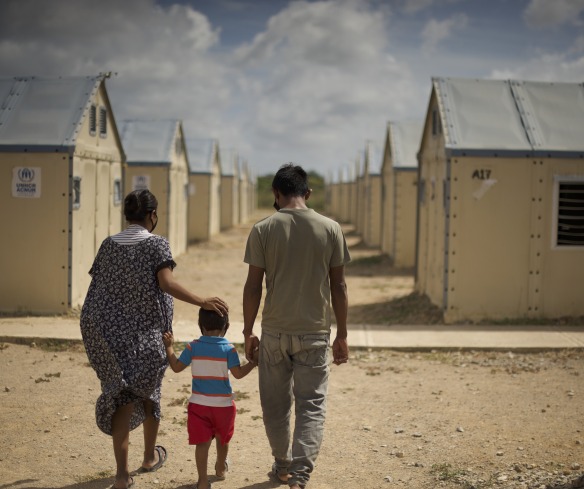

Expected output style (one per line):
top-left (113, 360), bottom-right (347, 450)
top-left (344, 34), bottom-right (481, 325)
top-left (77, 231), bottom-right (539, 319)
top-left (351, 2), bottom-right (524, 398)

top-left (0, 75), bottom-right (255, 314)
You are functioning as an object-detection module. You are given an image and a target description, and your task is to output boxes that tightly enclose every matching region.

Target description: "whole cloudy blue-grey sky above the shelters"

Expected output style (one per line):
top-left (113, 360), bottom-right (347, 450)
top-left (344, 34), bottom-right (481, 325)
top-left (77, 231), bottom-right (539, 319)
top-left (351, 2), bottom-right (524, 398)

top-left (0, 0), bottom-right (584, 178)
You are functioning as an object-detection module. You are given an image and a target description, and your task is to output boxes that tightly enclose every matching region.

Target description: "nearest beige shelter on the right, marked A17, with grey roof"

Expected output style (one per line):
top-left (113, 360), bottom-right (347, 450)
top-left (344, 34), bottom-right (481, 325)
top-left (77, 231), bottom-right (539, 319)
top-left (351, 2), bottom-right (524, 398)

top-left (416, 78), bottom-right (584, 322)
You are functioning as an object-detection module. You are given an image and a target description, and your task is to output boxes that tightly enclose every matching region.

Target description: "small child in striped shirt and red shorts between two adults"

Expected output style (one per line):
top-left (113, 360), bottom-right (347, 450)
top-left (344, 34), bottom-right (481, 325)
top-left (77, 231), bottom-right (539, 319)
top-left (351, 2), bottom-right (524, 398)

top-left (162, 309), bottom-right (257, 489)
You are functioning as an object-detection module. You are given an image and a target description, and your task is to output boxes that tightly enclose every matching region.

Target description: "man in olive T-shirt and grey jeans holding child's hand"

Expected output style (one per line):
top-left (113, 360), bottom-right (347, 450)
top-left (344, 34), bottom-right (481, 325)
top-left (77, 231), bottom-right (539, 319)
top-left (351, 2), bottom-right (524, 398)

top-left (243, 164), bottom-right (350, 489)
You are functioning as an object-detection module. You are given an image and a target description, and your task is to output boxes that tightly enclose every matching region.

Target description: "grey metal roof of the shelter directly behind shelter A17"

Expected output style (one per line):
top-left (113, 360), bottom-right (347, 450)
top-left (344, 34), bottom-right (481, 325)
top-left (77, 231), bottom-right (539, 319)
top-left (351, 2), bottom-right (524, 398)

top-left (387, 121), bottom-right (424, 170)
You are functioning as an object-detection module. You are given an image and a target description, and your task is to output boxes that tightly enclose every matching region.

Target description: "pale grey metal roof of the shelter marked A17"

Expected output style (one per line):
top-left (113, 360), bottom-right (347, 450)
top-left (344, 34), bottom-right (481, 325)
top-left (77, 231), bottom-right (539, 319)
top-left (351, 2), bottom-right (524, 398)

top-left (432, 78), bottom-right (584, 155)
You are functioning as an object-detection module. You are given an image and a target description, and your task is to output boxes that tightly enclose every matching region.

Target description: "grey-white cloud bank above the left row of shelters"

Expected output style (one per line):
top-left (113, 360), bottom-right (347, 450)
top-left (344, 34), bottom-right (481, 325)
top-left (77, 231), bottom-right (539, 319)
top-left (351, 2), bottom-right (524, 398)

top-left (0, 0), bottom-right (231, 141)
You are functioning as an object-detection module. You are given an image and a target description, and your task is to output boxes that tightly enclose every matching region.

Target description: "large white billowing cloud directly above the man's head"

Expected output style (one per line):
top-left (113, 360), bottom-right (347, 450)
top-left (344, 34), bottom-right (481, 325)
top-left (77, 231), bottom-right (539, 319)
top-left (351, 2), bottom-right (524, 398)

top-left (230, 1), bottom-right (415, 169)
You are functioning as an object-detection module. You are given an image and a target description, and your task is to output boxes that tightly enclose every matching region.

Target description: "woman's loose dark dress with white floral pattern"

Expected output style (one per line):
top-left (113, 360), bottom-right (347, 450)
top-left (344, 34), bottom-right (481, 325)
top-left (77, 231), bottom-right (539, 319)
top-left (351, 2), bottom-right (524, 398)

top-left (81, 235), bottom-right (176, 435)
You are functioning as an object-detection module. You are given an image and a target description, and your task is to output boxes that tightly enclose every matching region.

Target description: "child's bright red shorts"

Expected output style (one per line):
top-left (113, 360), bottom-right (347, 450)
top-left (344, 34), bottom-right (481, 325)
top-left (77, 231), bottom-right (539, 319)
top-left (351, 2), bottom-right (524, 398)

top-left (188, 402), bottom-right (236, 445)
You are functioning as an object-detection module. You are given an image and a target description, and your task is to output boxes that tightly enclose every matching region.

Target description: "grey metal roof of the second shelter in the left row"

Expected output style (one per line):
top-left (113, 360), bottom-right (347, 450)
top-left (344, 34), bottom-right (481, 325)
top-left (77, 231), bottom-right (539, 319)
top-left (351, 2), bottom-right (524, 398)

top-left (120, 119), bottom-right (180, 165)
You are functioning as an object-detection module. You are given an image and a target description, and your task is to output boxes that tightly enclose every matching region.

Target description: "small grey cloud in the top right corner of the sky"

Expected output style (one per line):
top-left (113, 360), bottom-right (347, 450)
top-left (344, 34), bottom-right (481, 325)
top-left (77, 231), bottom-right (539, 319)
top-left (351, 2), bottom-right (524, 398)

top-left (523, 0), bottom-right (584, 28)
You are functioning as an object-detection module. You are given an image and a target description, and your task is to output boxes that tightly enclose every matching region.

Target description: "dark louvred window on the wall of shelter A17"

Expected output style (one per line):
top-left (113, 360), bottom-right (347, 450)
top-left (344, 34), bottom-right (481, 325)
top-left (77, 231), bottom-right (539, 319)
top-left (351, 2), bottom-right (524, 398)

top-left (556, 178), bottom-right (584, 246)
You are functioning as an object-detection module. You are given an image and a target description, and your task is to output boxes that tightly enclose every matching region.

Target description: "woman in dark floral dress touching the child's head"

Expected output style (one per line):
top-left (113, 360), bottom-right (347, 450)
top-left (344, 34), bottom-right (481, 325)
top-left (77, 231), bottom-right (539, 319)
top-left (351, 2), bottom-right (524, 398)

top-left (81, 190), bottom-right (228, 489)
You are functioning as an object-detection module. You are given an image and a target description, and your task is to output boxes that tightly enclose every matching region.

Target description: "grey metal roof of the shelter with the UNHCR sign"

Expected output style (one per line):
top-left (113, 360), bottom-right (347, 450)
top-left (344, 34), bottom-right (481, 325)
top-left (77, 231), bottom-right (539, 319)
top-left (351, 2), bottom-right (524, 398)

top-left (0, 75), bottom-right (105, 149)
